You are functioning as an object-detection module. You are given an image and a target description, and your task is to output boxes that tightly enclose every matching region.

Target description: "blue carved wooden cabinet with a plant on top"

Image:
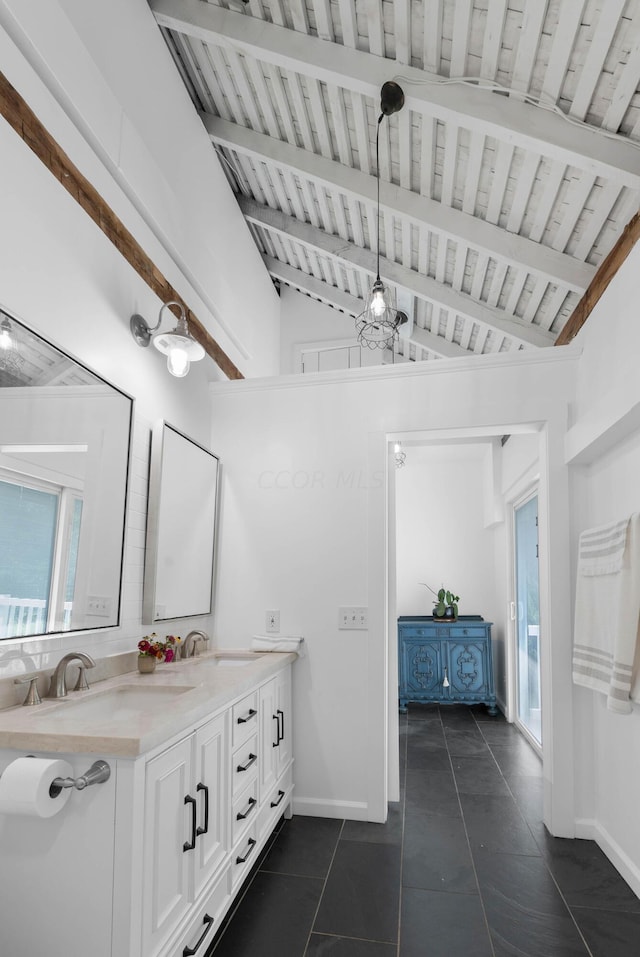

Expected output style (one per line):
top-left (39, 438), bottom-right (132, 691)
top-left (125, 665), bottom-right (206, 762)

top-left (398, 615), bottom-right (497, 714)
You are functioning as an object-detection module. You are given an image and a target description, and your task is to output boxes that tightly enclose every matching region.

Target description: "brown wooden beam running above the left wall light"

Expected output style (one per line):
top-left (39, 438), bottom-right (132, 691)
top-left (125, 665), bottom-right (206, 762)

top-left (0, 73), bottom-right (244, 379)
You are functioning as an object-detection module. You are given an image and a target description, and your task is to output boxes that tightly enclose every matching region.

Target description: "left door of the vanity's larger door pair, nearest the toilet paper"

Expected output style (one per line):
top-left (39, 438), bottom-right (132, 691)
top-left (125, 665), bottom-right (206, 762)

top-left (142, 736), bottom-right (197, 954)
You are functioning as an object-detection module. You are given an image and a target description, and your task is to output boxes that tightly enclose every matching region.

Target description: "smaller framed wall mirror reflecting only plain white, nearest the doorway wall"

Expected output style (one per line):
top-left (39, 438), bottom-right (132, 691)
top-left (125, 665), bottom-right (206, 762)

top-left (143, 422), bottom-right (219, 624)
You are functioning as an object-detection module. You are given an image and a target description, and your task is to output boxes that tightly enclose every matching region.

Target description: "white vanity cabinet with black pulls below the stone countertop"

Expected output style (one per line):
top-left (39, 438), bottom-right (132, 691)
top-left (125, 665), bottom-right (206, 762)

top-left (0, 656), bottom-right (293, 957)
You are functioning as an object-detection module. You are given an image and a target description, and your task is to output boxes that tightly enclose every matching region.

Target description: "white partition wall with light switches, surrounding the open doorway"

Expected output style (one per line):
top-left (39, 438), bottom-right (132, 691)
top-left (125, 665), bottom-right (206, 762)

top-left (212, 350), bottom-right (575, 833)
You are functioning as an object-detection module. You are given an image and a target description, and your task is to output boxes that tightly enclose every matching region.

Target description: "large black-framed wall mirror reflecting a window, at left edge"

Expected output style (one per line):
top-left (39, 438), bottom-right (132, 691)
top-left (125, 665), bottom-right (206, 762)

top-left (0, 311), bottom-right (133, 639)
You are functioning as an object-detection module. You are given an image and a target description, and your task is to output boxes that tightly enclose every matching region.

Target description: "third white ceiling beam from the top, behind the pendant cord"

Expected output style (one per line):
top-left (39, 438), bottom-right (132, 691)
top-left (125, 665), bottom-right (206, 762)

top-left (245, 197), bottom-right (554, 348)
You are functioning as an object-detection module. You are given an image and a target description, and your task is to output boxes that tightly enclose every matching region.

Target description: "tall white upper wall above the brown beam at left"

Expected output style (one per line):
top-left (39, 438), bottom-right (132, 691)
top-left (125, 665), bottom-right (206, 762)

top-left (0, 0), bottom-right (279, 376)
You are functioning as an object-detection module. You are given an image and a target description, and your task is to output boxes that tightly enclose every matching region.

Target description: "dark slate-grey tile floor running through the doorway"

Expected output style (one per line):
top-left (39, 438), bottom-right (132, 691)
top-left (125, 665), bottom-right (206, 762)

top-left (207, 705), bottom-right (640, 957)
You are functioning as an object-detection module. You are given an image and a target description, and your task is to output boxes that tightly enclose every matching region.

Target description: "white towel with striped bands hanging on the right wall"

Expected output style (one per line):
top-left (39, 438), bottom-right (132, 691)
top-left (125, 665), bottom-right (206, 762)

top-left (573, 513), bottom-right (640, 714)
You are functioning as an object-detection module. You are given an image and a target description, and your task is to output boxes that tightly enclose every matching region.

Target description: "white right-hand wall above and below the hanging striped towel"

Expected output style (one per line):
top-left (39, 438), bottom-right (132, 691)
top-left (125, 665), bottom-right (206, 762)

top-left (567, 246), bottom-right (640, 894)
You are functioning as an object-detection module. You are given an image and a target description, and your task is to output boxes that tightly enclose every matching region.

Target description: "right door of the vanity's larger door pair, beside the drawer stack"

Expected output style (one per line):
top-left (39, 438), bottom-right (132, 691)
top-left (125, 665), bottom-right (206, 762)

top-left (195, 712), bottom-right (229, 896)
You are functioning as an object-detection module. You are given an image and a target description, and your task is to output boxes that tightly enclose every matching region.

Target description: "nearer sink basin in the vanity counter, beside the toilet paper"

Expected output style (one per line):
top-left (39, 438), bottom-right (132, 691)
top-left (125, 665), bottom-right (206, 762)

top-left (35, 685), bottom-right (191, 724)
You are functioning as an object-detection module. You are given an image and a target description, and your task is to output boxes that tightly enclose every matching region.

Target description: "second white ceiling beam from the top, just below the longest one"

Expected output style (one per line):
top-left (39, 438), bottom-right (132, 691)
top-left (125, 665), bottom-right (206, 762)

top-left (208, 114), bottom-right (595, 293)
